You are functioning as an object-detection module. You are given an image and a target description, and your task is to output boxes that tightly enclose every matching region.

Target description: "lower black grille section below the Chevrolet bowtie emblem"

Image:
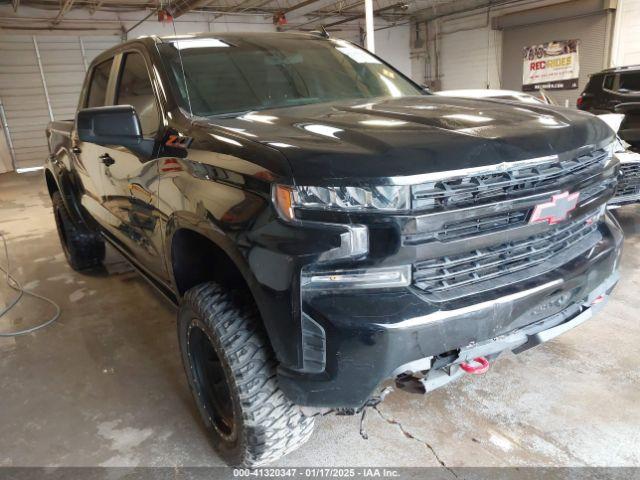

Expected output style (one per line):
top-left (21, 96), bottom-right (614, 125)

top-left (413, 216), bottom-right (598, 294)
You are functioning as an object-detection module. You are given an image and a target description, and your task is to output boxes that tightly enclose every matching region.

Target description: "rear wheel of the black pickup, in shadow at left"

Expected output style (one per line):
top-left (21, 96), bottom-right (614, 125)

top-left (51, 192), bottom-right (105, 271)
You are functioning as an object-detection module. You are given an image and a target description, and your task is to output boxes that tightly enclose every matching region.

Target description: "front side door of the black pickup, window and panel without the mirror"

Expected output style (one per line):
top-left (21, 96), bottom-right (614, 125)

top-left (96, 50), bottom-right (167, 282)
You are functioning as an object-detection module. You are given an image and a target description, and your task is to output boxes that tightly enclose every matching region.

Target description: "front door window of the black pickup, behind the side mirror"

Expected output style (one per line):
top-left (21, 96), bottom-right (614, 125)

top-left (116, 53), bottom-right (160, 137)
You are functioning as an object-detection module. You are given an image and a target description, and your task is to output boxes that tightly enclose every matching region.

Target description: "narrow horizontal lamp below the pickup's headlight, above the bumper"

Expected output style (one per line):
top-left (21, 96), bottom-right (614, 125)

top-left (300, 265), bottom-right (411, 289)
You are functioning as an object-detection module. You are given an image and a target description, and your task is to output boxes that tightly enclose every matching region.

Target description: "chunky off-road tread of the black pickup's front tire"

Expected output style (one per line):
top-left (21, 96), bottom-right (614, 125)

top-left (183, 282), bottom-right (314, 467)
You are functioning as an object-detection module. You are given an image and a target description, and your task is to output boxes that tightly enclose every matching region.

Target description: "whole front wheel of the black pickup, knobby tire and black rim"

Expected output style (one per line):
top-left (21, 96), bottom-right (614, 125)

top-left (178, 282), bottom-right (314, 467)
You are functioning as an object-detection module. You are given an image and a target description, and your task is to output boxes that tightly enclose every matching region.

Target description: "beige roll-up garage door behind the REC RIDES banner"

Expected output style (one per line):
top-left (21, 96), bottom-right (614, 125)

top-left (502, 12), bottom-right (608, 106)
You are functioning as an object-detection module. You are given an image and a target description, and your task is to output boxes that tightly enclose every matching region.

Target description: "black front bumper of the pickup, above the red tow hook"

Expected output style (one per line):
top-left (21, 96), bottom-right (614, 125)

top-left (279, 212), bottom-right (622, 408)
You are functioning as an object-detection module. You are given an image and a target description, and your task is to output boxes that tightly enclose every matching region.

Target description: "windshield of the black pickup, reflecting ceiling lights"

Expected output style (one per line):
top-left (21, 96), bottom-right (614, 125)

top-left (159, 36), bottom-right (422, 116)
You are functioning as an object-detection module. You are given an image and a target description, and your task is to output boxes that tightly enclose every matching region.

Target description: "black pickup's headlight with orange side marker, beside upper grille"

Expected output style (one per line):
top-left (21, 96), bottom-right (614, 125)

top-left (274, 185), bottom-right (411, 219)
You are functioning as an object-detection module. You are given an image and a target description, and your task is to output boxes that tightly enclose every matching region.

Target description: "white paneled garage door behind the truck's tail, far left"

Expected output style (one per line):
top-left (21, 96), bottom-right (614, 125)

top-left (0, 35), bottom-right (119, 169)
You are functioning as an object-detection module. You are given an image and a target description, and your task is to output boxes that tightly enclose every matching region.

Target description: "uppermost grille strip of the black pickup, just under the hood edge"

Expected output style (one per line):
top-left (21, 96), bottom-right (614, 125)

top-left (411, 149), bottom-right (608, 210)
